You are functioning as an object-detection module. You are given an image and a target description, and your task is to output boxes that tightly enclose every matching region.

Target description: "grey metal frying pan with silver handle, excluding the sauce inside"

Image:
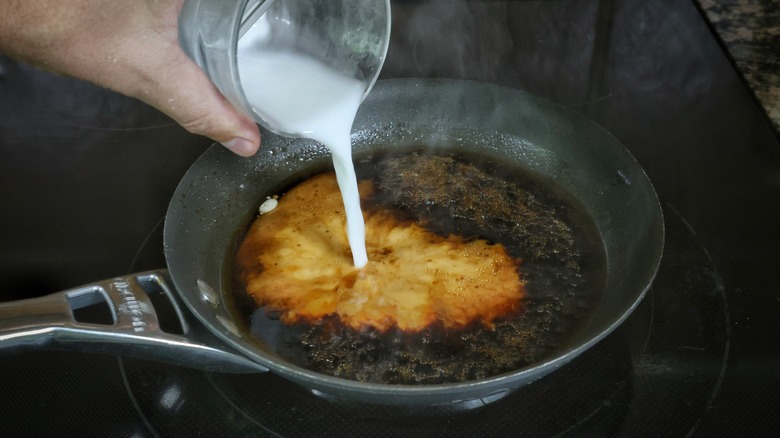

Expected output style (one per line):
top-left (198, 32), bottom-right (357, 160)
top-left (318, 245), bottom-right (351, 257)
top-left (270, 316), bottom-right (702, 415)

top-left (0, 79), bottom-right (664, 406)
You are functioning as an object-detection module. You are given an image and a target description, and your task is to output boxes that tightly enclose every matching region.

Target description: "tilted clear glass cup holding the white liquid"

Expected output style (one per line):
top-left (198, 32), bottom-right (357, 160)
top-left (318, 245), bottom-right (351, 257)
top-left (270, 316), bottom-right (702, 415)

top-left (179, 0), bottom-right (390, 136)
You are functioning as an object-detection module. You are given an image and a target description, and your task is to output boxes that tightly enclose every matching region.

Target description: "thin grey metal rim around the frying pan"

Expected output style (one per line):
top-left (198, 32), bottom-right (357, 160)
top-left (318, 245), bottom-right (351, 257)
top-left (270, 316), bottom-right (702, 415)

top-left (164, 79), bottom-right (665, 398)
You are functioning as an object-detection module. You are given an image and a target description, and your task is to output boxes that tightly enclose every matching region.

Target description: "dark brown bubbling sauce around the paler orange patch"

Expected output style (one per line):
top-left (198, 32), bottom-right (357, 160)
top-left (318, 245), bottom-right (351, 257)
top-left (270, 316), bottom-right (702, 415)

top-left (225, 149), bottom-right (606, 384)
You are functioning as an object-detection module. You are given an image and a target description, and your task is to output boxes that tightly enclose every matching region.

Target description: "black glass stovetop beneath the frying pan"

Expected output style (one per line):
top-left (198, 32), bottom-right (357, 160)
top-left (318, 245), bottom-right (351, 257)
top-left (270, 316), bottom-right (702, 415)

top-left (0, 0), bottom-right (780, 437)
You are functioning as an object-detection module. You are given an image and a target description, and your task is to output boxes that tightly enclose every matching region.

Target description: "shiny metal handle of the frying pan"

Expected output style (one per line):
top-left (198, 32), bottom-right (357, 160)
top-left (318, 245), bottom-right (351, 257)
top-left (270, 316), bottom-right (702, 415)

top-left (0, 270), bottom-right (268, 373)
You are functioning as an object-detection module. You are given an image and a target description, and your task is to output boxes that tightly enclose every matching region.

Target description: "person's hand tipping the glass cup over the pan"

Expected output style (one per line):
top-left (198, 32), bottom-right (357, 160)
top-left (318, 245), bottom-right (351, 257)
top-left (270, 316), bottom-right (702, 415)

top-left (0, 0), bottom-right (260, 156)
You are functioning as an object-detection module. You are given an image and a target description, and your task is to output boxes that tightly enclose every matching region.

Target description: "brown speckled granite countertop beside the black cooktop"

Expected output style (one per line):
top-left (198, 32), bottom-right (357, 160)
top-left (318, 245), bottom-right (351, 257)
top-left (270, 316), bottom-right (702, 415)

top-left (696, 0), bottom-right (780, 135)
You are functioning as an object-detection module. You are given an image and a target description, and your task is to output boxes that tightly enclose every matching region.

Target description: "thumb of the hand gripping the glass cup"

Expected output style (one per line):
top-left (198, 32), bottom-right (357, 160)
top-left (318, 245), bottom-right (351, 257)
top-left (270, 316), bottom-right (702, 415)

top-left (139, 51), bottom-right (260, 157)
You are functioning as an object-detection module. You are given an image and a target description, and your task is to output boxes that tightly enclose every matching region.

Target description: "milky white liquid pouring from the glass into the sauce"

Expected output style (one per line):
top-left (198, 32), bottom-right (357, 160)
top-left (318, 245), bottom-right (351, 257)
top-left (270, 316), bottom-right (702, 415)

top-left (238, 43), bottom-right (368, 268)
